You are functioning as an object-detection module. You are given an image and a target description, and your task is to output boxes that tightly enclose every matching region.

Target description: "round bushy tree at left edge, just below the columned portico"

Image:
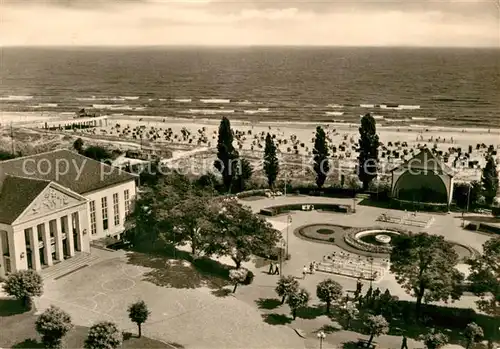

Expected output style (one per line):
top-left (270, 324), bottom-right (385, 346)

top-left (3, 270), bottom-right (43, 309)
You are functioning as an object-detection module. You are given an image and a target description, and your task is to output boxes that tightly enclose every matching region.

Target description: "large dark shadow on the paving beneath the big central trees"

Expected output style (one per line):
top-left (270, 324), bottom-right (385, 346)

top-left (127, 248), bottom-right (233, 289)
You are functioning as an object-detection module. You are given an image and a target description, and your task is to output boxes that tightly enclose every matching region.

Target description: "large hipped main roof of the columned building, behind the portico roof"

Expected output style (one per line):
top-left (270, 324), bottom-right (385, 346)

top-left (0, 149), bottom-right (137, 194)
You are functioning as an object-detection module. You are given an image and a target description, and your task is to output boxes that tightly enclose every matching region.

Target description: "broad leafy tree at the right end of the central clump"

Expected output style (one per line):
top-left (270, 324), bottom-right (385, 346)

top-left (206, 199), bottom-right (281, 269)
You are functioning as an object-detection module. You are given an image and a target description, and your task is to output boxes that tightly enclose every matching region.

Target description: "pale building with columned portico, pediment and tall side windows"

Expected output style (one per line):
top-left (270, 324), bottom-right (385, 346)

top-left (0, 150), bottom-right (137, 277)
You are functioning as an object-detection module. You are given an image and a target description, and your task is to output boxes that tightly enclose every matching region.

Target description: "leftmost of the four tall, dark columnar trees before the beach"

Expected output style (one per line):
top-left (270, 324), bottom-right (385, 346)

top-left (214, 116), bottom-right (239, 192)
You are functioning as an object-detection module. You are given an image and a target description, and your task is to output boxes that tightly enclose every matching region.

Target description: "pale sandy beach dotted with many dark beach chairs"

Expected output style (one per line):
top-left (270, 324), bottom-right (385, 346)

top-left (2, 113), bottom-right (500, 181)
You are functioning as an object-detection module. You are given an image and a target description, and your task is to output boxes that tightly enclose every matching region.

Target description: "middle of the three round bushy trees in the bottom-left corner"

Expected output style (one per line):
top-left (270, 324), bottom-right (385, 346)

top-left (35, 305), bottom-right (73, 349)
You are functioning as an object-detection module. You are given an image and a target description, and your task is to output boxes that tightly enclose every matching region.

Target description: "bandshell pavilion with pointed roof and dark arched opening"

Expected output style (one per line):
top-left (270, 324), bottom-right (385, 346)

top-left (391, 148), bottom-right (454, 207)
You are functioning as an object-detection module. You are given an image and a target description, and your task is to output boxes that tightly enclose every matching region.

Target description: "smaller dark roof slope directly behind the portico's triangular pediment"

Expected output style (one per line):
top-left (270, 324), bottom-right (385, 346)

top-left (0, 175), bottom-right (50, 224)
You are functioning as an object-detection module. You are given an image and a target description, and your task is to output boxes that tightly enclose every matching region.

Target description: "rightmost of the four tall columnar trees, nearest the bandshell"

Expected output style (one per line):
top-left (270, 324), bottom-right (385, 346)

top-left (358, 113), bottom-right (379, 191)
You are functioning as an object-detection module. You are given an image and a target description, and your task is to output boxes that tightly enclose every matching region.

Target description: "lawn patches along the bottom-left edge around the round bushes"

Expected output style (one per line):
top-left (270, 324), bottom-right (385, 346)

top-left (0, 299), bottom-right (178, 349)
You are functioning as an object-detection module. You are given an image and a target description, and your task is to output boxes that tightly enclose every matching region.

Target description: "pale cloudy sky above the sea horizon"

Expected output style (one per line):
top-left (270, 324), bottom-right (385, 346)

top-left (0, 0), bottom-right (500, 47)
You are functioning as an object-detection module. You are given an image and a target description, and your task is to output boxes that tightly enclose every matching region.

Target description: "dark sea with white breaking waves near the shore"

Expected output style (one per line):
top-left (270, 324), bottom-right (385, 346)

top-left (0, 47), bottom-right (500, 128)
